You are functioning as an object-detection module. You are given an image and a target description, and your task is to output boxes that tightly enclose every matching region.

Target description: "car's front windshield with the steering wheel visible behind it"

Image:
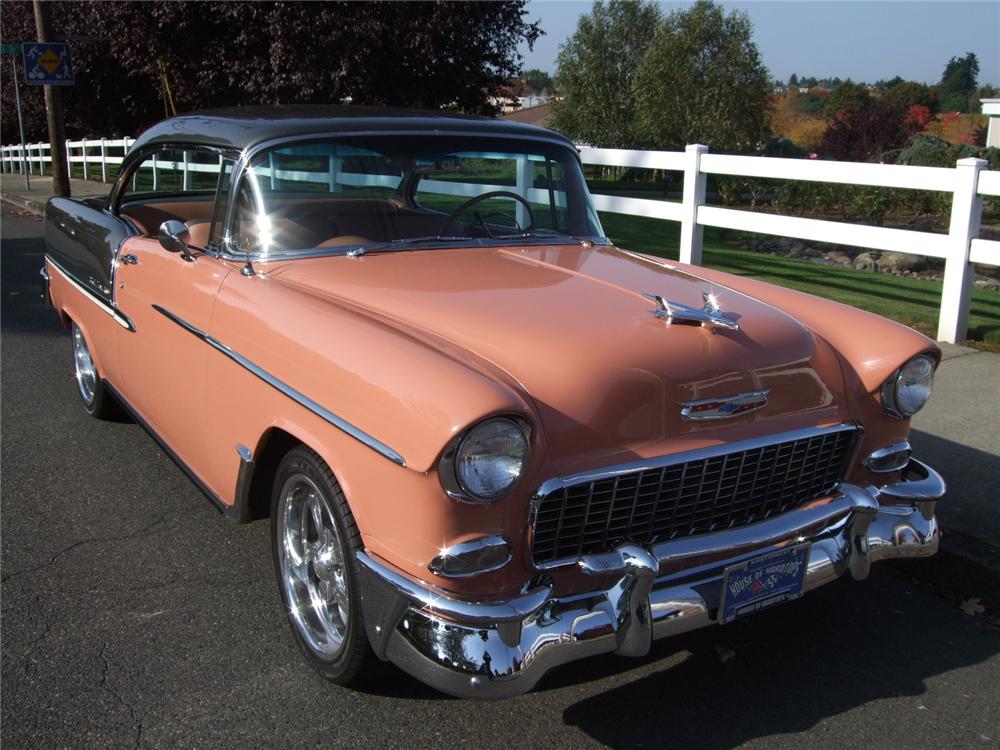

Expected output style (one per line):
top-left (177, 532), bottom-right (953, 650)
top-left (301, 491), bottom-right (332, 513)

top-left (230, 135), bottom-right (604, 255)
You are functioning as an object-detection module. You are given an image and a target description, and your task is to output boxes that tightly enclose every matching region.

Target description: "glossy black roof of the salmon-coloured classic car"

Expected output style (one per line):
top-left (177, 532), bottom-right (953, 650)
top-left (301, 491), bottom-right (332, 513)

top-left (133, 105), bottom-right (573, 151)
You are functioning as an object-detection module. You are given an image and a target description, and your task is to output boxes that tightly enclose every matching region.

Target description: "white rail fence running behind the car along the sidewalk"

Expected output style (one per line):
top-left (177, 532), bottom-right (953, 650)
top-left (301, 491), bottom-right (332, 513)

top-left (0, 138), bottom-right (1000, 343)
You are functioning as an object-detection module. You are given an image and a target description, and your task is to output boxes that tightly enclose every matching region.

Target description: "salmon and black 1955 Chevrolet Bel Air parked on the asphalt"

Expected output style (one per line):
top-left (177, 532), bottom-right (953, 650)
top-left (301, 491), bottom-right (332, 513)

top-left (42, 107), bottom-right (944, 698)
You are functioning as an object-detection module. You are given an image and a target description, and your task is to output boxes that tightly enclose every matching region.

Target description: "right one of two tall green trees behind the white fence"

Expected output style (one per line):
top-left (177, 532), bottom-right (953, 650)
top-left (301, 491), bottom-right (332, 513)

top-left (633, 0), bottom-right (771, 151)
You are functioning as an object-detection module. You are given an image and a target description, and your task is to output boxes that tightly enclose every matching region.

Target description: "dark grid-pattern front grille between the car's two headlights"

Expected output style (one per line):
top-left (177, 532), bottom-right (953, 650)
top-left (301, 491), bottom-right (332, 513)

top-left (533, 426), bottom-right (858, 564)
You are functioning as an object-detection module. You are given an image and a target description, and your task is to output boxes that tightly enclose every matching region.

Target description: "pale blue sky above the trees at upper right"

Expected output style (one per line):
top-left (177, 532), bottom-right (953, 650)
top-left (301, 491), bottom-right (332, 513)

top-left (521, 0), bottom-right (1000, 86)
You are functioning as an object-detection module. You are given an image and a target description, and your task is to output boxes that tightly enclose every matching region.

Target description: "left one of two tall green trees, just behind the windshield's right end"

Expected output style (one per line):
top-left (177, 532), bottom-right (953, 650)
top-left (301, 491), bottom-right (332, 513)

top-left (550, 0), bottom-right (660, 148)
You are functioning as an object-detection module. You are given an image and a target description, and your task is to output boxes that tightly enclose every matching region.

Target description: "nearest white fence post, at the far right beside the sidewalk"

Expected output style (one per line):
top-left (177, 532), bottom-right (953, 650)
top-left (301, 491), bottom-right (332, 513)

top-left (938, 158), bottom-right (988, 344)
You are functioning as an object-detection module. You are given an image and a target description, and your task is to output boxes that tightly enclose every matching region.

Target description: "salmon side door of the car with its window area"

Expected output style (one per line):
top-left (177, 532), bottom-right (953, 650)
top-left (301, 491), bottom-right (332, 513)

top-left (115, 150), bottom-right (233, 494)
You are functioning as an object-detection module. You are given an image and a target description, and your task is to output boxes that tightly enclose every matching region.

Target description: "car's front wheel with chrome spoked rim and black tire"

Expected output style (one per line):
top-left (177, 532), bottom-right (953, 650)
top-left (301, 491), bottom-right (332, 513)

top-left (271, 446), bottom-right (376, 685)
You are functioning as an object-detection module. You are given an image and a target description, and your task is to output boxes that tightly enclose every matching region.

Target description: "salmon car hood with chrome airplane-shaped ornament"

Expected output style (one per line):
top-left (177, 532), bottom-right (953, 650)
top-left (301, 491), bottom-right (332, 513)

top-left (269, 245), bottom-right (849, 472)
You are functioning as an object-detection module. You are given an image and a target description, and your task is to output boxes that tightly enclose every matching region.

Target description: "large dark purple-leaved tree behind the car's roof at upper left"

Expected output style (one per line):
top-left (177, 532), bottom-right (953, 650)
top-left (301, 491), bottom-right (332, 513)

top-left (2, 0), bottom-right (541, 142)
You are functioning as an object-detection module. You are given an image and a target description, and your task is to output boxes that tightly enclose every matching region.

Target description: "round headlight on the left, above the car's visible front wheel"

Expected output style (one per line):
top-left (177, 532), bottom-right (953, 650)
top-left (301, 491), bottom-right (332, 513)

top-left (454, 417), bottom-right (528, 501)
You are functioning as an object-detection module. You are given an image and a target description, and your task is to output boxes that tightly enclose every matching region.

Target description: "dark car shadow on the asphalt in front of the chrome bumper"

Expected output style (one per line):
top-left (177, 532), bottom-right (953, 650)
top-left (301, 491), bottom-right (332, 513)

top-left (560, 569), bottom-right (1000, 749)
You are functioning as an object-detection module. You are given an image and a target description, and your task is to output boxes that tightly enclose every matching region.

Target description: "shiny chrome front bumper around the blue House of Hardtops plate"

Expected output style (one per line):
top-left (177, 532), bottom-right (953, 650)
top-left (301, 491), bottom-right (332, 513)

top-left (358, 459), bottom-right (945, 698)
